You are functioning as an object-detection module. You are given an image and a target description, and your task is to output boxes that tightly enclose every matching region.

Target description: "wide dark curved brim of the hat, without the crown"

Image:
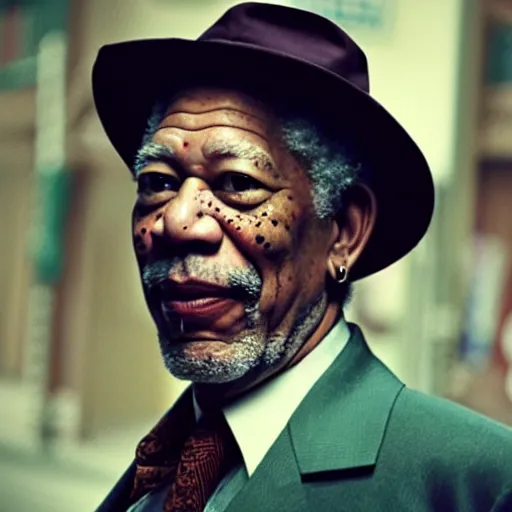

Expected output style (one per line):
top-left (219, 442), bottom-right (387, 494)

top-left (93, 39), bottom-right (434, 280)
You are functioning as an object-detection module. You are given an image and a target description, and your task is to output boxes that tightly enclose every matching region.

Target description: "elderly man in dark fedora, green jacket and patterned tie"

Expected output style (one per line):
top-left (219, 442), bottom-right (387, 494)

top-left (93, 3), bottom-right (512, 512)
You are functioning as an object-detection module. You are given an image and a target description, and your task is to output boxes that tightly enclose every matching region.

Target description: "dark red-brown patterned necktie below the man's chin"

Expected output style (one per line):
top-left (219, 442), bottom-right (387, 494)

top-left (132, 400), bottom-right (240, 512)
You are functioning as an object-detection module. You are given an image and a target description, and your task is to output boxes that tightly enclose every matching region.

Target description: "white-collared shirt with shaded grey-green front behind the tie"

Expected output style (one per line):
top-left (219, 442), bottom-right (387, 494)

top-left (129, 318), bottom-right (350, 512)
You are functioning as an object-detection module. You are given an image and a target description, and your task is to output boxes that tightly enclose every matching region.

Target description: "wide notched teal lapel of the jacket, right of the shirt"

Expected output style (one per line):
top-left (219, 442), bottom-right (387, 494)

top-left (290, 324), bottom-right (404, 475)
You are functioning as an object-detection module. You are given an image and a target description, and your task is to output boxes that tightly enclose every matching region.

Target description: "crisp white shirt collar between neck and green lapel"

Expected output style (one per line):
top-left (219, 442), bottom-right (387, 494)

top-left (208, 317), bottom-right (350, 477)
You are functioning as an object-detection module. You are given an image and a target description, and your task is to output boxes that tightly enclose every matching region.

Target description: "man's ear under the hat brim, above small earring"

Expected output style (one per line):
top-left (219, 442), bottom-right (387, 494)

top-left (327, 184), bottom-right (377, 279)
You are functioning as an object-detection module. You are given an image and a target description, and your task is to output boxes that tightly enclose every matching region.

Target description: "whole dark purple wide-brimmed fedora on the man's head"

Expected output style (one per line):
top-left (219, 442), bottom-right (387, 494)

top-left (92, 3), bottom-right (434, 280)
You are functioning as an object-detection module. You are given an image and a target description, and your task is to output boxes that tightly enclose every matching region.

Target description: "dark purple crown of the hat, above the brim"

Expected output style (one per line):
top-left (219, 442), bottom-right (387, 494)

top-left (198, 2), bottom-right (369, 92)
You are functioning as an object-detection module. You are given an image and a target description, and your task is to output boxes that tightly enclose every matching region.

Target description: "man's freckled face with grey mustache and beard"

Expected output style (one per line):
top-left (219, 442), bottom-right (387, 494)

top-left (133, 89), bottom-right (332, 383)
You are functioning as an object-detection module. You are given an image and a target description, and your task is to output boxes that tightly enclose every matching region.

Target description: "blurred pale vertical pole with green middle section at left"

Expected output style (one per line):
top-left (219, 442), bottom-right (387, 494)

top-left (26, 31), bottom-right (69, 448)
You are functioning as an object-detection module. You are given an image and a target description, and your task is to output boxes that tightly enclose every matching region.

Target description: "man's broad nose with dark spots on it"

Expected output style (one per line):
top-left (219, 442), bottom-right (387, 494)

top-left (153, 177), bottom-right (223, 245)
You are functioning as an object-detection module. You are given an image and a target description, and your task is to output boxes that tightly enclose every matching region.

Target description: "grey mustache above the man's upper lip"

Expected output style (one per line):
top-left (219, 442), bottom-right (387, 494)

top-left (142, 256), bottom-right (263, 300)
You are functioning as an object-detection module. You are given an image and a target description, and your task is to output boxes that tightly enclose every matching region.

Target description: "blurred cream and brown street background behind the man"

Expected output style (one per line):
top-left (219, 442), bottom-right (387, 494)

top-left (0, 0), bottom-right (512, 512)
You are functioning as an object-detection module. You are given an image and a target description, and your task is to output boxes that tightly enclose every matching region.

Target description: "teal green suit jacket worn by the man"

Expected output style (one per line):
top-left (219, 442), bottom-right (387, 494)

top-left (98, 325), bottom-right (512, 512)
